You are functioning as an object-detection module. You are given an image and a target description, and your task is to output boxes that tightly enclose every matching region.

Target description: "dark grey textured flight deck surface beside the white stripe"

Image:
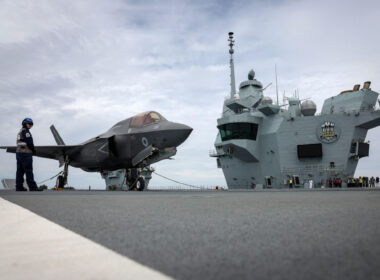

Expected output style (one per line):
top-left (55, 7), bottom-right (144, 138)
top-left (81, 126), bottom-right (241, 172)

top-left (0, 188), bottom-right (380, 280)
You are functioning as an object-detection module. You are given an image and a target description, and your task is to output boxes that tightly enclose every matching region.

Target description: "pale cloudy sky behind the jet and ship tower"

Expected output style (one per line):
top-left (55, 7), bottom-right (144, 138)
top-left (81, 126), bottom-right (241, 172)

top-left (0, 0), bottom-right (380, 188)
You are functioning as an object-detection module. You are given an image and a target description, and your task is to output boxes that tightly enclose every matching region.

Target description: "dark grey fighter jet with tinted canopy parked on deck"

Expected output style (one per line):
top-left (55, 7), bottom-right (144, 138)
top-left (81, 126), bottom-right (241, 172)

top-left (0, 111), bottom-right (193, 191)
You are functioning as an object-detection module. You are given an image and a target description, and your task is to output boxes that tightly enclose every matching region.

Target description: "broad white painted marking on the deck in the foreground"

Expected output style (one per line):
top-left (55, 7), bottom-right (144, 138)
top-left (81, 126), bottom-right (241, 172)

top-left (0, 197), bottom-right (171, 280)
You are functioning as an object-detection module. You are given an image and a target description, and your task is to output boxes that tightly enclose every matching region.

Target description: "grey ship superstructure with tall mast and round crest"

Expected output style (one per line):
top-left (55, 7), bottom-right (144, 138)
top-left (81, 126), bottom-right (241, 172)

top-left (210, 32), bottom-right (380, 189)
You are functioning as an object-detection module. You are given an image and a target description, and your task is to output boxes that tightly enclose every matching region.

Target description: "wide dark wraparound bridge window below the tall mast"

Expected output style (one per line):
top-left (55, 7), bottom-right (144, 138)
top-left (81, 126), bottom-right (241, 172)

top-left (218, 123), bottom-right (259, 141)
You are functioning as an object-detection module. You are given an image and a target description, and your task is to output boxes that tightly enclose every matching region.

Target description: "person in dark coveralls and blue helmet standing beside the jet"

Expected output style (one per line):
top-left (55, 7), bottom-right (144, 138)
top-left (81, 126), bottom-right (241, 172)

top-left (16, 118), bottom-right (39, 191)
